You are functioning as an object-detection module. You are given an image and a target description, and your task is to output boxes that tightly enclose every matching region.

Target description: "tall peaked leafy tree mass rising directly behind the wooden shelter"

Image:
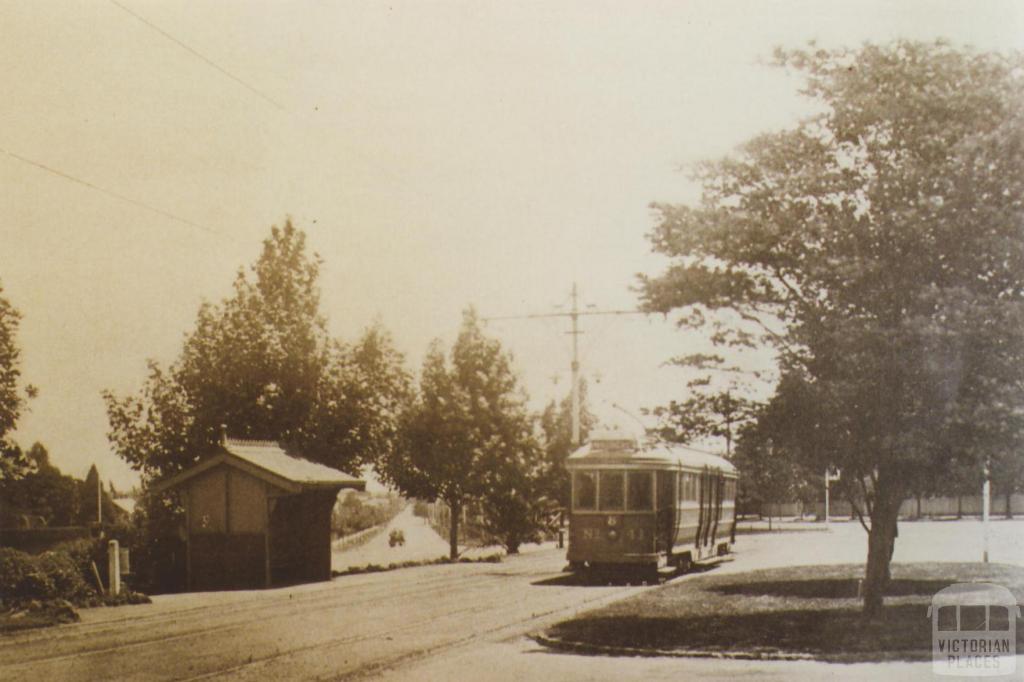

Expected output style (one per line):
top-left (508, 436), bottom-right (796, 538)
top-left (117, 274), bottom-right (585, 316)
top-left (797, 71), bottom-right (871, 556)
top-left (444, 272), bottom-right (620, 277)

top-left (103, 221), bottom-right (409, 476)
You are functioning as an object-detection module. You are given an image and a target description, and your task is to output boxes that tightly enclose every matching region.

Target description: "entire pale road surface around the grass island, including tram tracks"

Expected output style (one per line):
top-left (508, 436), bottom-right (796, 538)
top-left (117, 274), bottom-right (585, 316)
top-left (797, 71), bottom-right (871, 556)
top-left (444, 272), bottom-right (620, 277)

top-left (0, 521), bottom-right (1024, 682)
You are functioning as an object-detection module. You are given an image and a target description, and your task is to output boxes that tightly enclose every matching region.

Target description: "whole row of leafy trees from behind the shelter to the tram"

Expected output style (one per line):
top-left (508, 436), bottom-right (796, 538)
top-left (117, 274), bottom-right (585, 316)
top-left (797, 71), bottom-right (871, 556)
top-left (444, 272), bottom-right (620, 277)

top-left (103, 221), bottom-right (589, 557)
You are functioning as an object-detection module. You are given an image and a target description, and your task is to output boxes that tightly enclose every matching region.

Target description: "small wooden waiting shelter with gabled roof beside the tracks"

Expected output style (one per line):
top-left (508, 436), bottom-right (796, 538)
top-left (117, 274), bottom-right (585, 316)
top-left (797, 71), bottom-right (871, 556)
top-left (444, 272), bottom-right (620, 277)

top-left (154, 436), bottom-right (366, 591)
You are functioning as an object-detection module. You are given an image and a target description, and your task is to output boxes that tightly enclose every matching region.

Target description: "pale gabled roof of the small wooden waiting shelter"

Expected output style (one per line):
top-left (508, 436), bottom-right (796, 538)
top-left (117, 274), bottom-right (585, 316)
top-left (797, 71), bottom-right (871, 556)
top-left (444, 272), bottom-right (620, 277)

top-left (154, 438), bottom-right (367, 493)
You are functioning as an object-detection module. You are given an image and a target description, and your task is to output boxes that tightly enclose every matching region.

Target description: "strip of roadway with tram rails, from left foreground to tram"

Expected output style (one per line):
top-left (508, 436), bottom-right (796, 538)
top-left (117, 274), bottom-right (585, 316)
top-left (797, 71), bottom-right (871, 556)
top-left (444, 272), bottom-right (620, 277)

top-left (0, 550), bottom-right (644, 682)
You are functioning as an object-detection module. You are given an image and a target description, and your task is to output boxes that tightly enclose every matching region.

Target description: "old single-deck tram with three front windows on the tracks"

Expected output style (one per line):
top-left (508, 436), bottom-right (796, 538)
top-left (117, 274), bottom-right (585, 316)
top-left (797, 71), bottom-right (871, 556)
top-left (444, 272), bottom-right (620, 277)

top-left (566, 432), bottom-right (736, 573)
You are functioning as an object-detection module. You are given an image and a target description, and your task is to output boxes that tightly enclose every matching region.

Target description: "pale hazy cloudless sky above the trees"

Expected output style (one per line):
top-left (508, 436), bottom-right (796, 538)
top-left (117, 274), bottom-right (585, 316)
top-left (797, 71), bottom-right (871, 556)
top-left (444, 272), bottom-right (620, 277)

top-left (0, 0), bottom-right (1024, 486)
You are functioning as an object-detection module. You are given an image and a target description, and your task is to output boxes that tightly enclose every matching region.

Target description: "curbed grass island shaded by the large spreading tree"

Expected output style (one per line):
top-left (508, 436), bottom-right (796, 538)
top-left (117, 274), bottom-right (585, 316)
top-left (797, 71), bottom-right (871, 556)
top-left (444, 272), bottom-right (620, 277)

top-left (545, 563), bottom-right (1024, 663)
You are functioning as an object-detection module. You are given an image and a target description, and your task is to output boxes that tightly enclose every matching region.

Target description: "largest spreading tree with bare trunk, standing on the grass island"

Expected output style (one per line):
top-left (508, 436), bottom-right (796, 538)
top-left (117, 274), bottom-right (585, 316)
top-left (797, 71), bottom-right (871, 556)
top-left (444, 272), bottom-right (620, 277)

top-left (642, 41), bottom-right (1024, 617)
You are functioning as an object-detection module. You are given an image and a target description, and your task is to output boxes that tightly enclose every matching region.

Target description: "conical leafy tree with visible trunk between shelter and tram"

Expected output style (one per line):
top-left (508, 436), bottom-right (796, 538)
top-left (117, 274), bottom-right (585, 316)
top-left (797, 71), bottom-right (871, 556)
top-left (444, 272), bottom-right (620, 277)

top-left (378, 308), bottom-right (541, 559)
